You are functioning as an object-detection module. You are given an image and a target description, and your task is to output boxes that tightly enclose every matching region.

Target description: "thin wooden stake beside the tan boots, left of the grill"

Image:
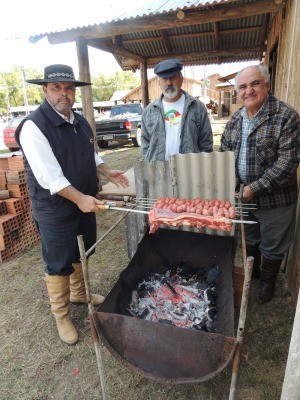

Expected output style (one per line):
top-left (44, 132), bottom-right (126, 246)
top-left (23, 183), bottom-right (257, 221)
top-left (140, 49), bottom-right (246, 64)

top-left (77, 235), bottom-right (108, 400)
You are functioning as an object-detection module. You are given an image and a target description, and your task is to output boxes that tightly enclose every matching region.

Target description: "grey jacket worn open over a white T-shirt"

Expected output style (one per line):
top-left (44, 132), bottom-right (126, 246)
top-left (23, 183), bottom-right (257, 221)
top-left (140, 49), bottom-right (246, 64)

top-left (141, 90), bottom-right (213, 161)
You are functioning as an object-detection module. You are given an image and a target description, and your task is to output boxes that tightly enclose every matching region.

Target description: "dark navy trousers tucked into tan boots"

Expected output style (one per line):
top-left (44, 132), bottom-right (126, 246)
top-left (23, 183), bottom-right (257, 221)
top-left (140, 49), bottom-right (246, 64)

top-left (36, 213), bottom-right (96, 275)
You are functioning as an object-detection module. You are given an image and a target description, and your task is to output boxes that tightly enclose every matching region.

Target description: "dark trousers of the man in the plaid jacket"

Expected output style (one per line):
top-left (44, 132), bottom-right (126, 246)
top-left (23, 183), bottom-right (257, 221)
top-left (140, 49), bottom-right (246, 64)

top-left (245, 204), bottom-right (296, 260)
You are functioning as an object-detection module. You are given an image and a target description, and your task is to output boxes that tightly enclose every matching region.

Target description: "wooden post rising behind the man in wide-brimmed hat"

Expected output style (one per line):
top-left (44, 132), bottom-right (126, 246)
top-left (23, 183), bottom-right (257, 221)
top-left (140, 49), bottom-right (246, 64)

top-left (76, 37), bottom-right (98, 151)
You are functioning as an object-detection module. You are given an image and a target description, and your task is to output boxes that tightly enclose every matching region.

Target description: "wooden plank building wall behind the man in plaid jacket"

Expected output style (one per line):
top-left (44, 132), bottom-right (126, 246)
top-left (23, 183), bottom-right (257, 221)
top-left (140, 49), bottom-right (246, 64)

top-left (266, 0), bottom-right (300, 307)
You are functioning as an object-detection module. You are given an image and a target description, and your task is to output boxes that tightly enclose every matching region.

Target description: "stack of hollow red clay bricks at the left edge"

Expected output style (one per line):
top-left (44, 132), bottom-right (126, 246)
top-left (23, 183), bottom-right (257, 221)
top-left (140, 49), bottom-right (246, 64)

top-left (0, 156), bottom-right (39, 262)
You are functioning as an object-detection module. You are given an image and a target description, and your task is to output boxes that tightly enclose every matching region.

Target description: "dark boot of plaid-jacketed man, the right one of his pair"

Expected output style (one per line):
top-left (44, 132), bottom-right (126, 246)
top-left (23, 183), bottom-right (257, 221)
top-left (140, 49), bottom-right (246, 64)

top-left (257, 257), bottom-right (282, 304)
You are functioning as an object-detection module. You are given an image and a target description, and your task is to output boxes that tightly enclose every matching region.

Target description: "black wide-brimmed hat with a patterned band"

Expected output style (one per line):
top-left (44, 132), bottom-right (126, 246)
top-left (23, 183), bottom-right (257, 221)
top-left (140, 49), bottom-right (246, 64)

top-left (26, 64), bottom-right (91, 86)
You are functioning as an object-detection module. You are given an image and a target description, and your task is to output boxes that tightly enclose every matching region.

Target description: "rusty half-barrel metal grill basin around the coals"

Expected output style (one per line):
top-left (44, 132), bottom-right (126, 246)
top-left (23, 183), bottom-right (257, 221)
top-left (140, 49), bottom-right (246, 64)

top-left (93, 229), bottom-right (236, 384)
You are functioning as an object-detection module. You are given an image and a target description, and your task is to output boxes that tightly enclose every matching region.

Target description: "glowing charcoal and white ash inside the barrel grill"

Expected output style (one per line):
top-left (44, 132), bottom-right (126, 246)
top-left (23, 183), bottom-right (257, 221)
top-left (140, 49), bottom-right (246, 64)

top-left (127, 267), bottom-right (216, 331)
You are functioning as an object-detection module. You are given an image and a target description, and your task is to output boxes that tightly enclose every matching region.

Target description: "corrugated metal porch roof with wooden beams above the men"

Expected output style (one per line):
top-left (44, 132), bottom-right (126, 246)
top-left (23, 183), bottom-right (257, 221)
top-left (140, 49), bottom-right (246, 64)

top-left (27, 0), bottom-right (281, 70)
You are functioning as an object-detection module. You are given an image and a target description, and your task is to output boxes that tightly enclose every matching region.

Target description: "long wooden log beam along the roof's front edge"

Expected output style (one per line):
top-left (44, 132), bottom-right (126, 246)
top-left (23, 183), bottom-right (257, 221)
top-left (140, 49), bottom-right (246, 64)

top-left (45, 0), bottom-right (285, 44)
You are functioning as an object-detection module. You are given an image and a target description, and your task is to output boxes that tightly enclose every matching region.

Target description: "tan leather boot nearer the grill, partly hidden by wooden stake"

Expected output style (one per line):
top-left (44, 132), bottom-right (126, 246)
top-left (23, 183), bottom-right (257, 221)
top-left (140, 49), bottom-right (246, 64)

top-left (70, 263), bottom-right (105, 306)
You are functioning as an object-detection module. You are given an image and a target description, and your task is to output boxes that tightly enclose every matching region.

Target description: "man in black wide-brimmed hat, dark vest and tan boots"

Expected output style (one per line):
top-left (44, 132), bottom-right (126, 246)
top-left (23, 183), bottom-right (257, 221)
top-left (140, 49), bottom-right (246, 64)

top-left (16, 64), bottom-right (128, 345)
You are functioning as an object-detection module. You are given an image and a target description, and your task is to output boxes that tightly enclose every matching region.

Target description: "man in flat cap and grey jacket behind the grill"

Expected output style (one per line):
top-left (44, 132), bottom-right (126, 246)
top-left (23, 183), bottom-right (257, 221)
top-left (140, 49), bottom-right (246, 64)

top-left (141, 59), bottom-right (213, 161)
